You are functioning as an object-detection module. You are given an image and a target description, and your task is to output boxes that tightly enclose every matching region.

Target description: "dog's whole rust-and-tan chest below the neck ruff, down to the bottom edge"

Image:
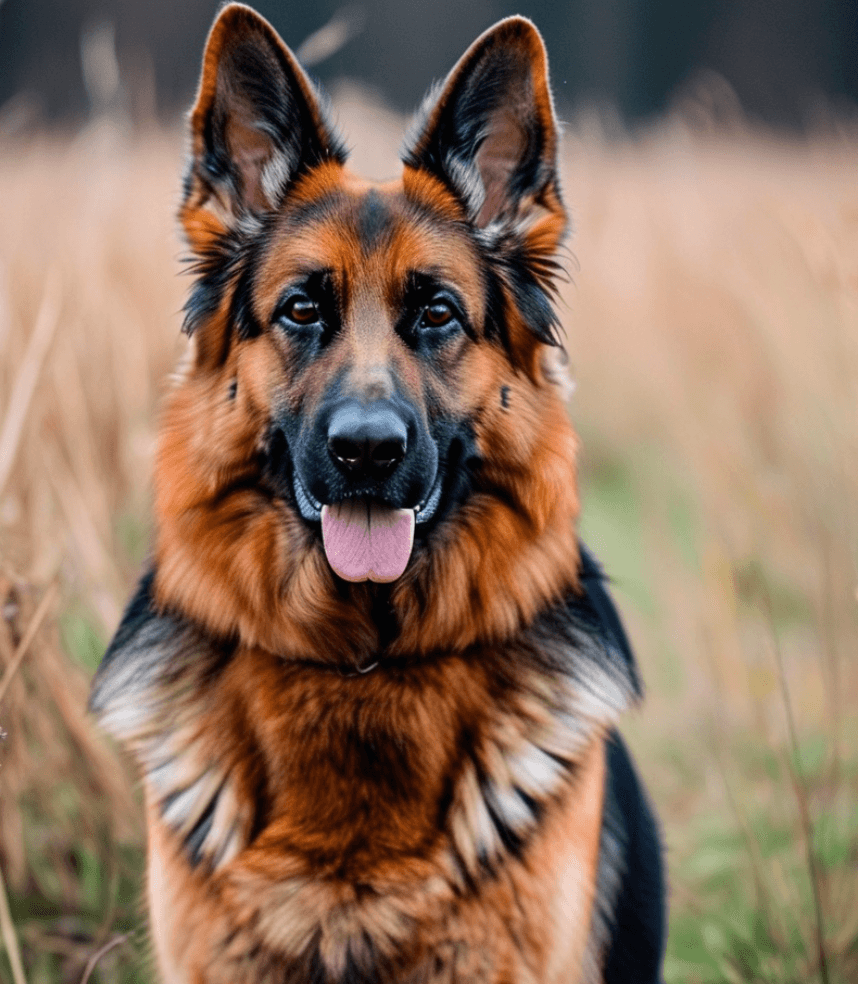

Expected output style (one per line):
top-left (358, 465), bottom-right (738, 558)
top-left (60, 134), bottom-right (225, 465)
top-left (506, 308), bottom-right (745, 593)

top-left (142, 655), bottom-right (620, 984)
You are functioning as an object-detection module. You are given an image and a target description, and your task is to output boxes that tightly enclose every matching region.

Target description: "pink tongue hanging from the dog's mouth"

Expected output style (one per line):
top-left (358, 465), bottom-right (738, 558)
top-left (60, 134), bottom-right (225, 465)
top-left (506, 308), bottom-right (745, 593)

top-left (322, 499), bottom-right (414, 581)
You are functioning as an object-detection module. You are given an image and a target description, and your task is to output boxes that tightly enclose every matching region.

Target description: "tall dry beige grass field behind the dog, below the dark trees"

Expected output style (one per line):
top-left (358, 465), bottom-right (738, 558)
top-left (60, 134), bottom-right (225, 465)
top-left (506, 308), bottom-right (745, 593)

top-left (0, 90), bottom-right (858, 984)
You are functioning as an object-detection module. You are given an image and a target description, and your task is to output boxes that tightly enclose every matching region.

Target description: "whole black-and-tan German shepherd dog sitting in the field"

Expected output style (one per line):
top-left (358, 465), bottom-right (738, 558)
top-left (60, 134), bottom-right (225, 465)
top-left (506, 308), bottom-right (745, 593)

top-left (92, 4), bottom-right (665, 984)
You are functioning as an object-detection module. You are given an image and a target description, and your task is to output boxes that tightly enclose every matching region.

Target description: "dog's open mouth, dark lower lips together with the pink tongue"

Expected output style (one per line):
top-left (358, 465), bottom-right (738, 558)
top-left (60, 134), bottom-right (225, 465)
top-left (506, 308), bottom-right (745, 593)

top-left (292, 468), bottom-right (443, 583)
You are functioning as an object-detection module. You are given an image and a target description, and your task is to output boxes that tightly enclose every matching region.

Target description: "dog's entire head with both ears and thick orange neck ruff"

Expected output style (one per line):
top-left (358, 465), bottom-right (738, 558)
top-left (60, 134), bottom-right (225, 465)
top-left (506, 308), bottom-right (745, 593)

top-left (156, 4), bottom-right (577, 652)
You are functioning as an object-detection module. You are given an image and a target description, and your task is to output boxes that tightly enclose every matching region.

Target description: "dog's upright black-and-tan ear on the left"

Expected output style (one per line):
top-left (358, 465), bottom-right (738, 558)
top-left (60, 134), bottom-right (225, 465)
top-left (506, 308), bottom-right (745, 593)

top-left (181, 3), bottom-right (346, 246)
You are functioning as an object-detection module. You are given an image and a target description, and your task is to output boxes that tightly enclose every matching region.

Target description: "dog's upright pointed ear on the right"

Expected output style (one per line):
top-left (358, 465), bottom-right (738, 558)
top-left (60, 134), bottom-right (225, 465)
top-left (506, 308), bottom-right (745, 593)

top-left (403, 17), bottom-right (565, 228)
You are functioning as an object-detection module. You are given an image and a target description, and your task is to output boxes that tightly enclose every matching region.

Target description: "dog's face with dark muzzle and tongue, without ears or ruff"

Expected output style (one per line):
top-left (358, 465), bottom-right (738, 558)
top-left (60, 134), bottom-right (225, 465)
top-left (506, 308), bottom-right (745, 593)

top-left (237, 177), bottom-right (484, 581)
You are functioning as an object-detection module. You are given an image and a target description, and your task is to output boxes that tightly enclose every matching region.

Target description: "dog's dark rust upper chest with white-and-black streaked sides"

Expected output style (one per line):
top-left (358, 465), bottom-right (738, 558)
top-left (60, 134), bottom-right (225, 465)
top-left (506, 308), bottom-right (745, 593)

top-left (181, 653), bottom-right (615, 876)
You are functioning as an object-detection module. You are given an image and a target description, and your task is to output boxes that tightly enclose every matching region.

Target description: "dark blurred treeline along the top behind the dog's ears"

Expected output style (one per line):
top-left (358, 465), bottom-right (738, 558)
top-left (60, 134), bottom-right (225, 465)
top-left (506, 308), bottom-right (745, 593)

top-left (0, 0), bottom-right (858, 127)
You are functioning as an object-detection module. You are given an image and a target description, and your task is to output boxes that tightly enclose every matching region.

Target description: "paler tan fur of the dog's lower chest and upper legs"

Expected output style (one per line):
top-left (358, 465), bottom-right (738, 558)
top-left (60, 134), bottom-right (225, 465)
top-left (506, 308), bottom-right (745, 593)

top-left (145, 739), bottom-right (604, 984)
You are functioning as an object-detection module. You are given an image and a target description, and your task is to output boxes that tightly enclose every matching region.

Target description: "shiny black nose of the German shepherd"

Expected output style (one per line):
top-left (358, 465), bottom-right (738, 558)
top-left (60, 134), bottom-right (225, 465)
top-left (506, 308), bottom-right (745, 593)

top-left (328, 402), bottom-right (408, 479)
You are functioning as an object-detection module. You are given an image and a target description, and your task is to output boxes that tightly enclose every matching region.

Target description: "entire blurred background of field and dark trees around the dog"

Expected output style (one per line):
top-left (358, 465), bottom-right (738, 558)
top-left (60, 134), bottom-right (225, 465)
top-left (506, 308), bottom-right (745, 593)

top-left (0, 0), bottom-right (858, 984)
